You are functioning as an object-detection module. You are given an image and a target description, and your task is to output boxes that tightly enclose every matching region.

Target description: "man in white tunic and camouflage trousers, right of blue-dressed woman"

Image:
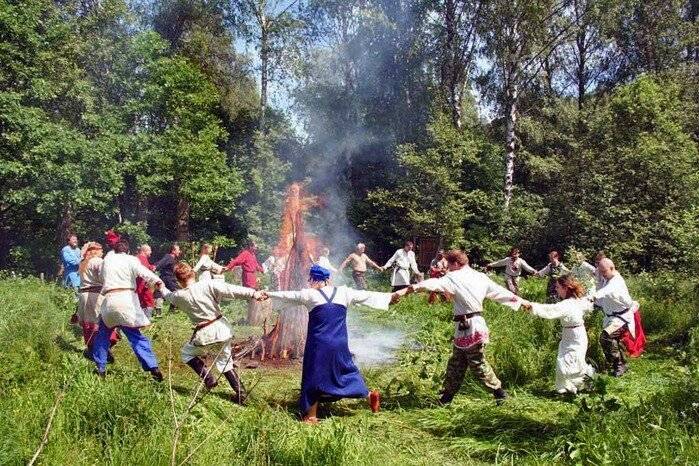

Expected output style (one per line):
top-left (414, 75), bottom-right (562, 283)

top-left (397, 250), bottom-right (521, 403)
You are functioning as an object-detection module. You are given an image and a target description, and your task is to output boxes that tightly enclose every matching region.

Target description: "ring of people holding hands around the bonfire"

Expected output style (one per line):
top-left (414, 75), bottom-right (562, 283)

top-left (61, 230), bottom-right (645, 423)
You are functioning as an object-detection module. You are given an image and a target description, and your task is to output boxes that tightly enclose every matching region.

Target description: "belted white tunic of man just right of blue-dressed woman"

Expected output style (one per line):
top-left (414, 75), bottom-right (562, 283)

top-left (413, 266), bottom-right (522, 348)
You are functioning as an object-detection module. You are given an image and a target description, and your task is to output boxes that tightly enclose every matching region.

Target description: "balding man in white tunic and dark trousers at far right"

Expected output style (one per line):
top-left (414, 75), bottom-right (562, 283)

top-left (593, 258), bottom-right (637, 377)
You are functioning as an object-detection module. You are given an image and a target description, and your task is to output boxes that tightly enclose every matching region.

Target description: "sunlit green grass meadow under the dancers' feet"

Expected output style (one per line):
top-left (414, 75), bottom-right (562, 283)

top-left (0, 275), bottom-right (699, 465)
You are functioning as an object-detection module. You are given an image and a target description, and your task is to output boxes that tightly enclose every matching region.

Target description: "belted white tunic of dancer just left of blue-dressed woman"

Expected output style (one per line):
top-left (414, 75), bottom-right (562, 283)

top-left (161, 280), bottom-right (255, 346)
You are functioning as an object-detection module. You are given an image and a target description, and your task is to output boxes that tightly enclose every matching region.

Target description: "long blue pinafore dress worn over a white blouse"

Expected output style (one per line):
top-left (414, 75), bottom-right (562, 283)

top-left (299, 288), bottom-right (369, 415)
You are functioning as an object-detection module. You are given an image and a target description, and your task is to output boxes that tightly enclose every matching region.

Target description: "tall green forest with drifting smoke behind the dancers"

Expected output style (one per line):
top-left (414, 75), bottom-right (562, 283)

top-left (0, 0), bottom-right (699, 276)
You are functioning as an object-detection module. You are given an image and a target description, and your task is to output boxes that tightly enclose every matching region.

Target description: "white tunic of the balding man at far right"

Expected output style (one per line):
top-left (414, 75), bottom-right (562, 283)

top-left (593, 272), bottom-right (638, 338)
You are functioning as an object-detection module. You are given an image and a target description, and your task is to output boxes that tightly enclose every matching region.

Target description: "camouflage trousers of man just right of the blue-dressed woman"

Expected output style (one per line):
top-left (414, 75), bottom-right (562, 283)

top-left (442, 344), bottom-right (502, 399)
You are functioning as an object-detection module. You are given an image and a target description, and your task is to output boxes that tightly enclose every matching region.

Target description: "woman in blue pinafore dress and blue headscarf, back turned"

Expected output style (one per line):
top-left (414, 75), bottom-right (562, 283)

top-left (265, 265), bottom-right (398, 424)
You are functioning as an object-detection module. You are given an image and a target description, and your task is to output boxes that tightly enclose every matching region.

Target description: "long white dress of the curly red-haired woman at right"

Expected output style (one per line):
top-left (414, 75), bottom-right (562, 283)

top-left (532, 297), bottom-right (595, 393)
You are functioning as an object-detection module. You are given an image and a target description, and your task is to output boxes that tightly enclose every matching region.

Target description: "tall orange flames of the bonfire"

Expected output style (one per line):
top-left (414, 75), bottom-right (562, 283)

top-left (273, 183), bottom-right (319, 290)
